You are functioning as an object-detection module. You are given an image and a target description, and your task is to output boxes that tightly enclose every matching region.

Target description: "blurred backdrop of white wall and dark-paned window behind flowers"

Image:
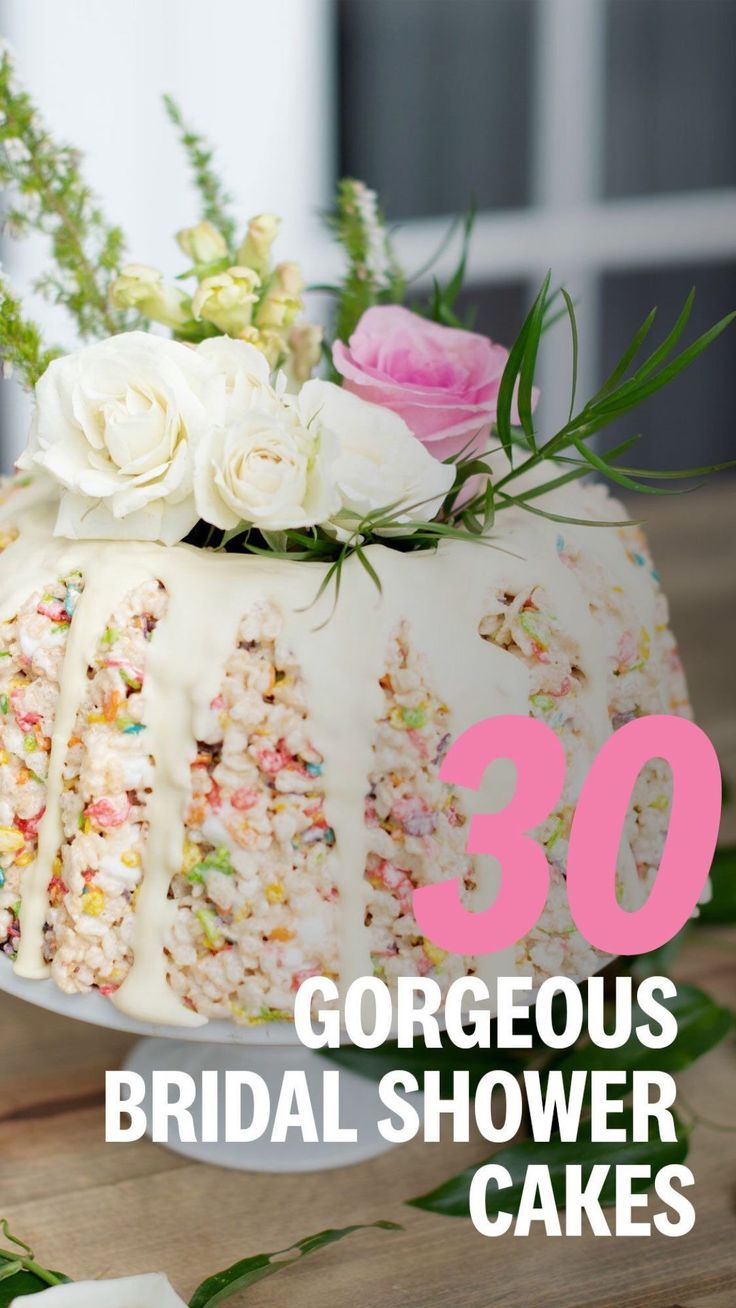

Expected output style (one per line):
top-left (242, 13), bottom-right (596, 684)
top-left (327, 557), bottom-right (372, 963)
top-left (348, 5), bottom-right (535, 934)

top-left (0, 0), bottom-right (736, 467)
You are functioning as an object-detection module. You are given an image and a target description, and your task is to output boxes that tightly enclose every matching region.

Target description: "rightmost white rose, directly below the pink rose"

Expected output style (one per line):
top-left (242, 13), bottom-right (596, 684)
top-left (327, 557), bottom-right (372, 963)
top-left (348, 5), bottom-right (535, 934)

top-left (297, 379), bottom-right (455, 526)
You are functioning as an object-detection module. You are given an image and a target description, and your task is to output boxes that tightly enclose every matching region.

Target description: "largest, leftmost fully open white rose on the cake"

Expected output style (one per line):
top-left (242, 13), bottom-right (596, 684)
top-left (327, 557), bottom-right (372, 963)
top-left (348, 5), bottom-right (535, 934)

top-left (18, 332), bottom-right (212, 544)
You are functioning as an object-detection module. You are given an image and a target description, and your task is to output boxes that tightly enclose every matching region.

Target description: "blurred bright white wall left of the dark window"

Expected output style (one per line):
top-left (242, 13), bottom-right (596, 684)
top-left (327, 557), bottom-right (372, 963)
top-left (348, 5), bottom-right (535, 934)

top-left (0, 0), bottom-right (335, 463)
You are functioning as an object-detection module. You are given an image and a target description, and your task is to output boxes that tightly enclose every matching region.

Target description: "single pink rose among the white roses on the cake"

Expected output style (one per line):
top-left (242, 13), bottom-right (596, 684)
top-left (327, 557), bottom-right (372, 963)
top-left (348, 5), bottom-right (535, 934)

top-left (332, 305), bottom-right (522, 459)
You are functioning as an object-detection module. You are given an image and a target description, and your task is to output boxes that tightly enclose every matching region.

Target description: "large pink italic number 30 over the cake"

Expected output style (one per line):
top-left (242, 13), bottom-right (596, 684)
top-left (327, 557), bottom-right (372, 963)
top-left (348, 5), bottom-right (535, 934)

top-left (414, 714), bottom-right (722, 954)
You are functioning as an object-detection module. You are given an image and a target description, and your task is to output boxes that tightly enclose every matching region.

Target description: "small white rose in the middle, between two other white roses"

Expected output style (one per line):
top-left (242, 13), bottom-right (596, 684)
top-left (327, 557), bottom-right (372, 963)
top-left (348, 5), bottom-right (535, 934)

top-left (195, 385), bottom-right (337, 531)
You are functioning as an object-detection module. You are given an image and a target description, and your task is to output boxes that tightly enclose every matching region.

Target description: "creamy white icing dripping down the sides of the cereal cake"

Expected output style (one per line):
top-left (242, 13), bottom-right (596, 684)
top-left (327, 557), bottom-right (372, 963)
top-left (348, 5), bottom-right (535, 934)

top-left (0, 476), bottom-right (654, 1025)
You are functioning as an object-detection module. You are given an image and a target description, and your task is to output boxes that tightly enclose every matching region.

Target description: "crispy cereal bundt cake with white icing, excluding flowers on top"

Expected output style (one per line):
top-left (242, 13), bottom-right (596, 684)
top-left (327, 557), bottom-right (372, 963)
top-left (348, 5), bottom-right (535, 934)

top-left (0, 477), bottom-right (689, 1025)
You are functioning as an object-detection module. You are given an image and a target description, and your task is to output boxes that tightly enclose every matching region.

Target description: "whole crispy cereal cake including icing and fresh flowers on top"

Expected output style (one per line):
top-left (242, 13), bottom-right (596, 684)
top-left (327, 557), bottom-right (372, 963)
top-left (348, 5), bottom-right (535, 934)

top-left (0, 68), bottom-right (733, 1027)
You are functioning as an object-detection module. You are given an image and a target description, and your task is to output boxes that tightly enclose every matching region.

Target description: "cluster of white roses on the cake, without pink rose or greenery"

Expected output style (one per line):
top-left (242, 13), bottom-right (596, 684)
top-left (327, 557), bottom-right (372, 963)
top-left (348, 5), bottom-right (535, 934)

top-left (18, 331), bottom-right (452, 545)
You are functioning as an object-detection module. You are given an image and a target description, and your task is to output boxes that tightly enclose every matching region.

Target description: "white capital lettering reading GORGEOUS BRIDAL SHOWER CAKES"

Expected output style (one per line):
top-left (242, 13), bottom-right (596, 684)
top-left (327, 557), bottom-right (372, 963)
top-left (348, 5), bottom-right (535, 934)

top-left (106, 976), bottom-right (694, 1236)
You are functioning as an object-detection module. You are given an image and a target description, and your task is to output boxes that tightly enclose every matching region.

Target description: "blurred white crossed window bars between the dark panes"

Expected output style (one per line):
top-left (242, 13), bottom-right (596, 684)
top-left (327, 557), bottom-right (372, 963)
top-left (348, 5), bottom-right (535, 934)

top-left (329, 0), bottom-right (736, 423)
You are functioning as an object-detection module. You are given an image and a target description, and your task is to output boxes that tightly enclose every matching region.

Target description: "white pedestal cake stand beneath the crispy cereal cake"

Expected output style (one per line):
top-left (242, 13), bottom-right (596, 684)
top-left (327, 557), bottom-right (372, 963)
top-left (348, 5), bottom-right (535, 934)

top-left (0, 955), bottom-right (421, 1172)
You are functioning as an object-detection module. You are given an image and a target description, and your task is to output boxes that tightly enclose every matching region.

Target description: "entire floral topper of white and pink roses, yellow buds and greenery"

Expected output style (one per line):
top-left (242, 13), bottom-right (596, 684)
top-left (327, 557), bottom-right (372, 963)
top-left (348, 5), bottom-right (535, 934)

top-left (0, 35), bottom-right (733, 596)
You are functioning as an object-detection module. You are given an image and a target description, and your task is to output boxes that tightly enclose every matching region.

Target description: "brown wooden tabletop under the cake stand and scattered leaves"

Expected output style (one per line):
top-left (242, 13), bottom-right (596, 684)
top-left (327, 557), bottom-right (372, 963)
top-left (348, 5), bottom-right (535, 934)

top-left (0, 484), bottom-right (736, 1308)
